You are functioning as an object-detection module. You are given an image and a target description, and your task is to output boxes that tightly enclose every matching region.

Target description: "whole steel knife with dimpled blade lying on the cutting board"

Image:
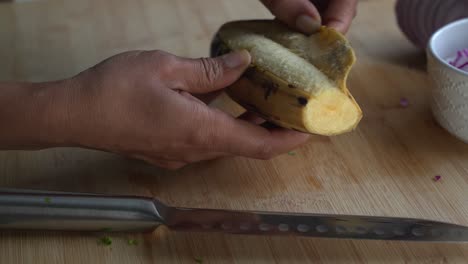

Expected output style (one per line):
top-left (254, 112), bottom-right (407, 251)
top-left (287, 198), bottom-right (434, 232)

top-left (0, 189), bottom-right (468, 242)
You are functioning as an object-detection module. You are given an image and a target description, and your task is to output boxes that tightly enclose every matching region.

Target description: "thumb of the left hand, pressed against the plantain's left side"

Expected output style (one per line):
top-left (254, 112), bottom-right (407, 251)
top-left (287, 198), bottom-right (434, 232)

top-left (179, 50), bottom-right (251, 94)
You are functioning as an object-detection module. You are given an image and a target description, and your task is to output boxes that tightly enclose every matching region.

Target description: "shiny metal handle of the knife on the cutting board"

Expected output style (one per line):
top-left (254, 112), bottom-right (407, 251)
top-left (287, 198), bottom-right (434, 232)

top-left (0, 190), bottom-right (163, 232)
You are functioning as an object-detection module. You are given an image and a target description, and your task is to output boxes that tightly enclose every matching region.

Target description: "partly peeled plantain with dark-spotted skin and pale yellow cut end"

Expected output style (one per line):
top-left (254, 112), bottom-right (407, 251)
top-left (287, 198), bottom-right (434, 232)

top-left (210, 20), bottom-right (362, 136)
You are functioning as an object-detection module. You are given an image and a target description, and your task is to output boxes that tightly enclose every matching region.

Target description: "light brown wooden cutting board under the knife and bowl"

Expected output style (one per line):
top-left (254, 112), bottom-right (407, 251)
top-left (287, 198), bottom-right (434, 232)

top-left (0, 0), bottom-right (468, 264)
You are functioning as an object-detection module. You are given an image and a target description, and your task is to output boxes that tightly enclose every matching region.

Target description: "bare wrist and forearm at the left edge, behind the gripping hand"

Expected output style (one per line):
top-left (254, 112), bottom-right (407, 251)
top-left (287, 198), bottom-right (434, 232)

top-left (0, 80), bottom-right (78, 149)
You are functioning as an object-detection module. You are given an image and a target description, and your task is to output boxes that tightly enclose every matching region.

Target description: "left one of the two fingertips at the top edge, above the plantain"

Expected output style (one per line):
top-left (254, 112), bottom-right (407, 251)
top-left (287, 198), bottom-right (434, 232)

top-left (261, 0), bottom-right (321, 34)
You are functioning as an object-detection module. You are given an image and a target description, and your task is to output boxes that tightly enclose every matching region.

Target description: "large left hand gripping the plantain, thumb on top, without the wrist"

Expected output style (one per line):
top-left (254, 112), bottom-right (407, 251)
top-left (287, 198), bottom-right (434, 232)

top-left (61, 51), bottom-right (308, 169)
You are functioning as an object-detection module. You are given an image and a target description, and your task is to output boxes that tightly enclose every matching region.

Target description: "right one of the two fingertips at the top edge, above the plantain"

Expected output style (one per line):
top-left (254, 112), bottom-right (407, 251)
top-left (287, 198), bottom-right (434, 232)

top-left (323, 0), bottom-right (358, 33)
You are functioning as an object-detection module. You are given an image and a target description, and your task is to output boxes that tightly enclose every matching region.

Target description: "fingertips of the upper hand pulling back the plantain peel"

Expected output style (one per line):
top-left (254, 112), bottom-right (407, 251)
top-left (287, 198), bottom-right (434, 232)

top-left (261, 0), bottom-right (358, 34)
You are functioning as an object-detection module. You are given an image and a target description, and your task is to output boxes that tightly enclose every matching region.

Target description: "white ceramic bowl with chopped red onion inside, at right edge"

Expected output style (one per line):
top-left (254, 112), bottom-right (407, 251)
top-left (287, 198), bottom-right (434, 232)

top-left (427, 18), bottom-right (468, 143)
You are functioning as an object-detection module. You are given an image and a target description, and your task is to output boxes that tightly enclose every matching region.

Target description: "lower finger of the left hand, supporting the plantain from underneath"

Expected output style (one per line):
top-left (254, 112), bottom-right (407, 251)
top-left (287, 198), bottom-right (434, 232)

top-left (204, 110), bottom-right (309, 159)
